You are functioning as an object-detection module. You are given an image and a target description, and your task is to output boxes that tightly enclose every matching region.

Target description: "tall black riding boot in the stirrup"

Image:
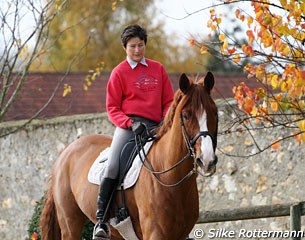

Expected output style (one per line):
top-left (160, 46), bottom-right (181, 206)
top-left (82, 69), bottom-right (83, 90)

top-left (92, 178), bottom-right (116, 240)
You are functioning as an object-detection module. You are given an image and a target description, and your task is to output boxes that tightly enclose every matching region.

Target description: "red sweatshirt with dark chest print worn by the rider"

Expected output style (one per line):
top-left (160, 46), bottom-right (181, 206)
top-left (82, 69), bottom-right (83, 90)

top-left (106, 58), bottom-right (174, 128)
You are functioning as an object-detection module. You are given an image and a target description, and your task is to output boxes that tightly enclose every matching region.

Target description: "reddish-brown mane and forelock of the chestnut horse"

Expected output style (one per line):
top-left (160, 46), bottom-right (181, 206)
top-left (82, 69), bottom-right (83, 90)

top-left (157, 75), bottom-right (216, 139)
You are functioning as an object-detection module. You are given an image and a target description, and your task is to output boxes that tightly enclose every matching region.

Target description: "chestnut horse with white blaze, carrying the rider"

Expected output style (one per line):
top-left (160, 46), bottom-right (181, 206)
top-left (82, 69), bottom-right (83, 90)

top-left (40, 72), bottom-right (218, 240)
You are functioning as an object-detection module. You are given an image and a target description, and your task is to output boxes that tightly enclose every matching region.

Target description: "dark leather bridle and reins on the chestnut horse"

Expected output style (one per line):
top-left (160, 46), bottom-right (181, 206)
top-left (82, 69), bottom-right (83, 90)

top-left (135, 114), bottom-right (217, 187)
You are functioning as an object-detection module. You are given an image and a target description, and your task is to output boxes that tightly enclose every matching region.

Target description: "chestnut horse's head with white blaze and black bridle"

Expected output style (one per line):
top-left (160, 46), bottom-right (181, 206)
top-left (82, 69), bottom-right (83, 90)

top-left (176, 72), bottom-right (218, 176)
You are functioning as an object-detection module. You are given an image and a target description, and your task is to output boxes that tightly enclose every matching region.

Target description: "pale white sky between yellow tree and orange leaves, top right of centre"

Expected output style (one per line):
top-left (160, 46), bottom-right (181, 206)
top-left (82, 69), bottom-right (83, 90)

top-left (155, 0), bottom-right (252, 44)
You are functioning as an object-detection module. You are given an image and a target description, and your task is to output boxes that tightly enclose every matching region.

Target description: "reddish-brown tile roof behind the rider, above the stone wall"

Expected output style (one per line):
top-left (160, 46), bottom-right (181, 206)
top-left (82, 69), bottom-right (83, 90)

top-left (1, 73), bottom-right (258, 120)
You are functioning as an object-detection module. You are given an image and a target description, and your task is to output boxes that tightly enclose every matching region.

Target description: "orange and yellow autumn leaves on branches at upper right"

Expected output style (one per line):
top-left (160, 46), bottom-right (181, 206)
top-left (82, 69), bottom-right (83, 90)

top-left (219, 0), bottom-right (305, 149)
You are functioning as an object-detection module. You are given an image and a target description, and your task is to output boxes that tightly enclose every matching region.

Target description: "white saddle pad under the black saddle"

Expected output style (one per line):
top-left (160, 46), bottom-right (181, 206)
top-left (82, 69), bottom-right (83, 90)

top-left (88, 141), bottom-right (153, 189)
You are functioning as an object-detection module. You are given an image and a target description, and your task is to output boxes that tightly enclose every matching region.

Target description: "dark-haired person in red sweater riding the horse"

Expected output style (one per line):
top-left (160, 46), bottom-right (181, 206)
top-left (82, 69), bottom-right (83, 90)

top-left (93, 25), bottom-right (174, 240)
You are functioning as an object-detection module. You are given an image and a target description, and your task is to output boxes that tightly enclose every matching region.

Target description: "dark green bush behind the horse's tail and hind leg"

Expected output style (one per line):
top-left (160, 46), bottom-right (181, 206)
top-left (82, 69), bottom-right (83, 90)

top-left (28, 197), bottom-right (94, 240)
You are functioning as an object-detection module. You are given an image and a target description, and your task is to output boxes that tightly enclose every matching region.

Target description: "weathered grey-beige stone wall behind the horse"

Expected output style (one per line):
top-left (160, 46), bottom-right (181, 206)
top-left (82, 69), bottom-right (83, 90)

top-left (0, 104), bottom-right (305, 240)
